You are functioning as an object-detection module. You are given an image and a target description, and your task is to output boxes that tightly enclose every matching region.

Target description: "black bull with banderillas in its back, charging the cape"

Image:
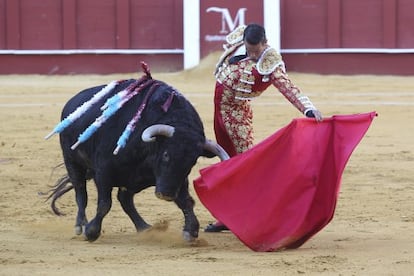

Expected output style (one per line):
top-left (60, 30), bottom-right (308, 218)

top-left (50, 69), bottom-right (228, 241)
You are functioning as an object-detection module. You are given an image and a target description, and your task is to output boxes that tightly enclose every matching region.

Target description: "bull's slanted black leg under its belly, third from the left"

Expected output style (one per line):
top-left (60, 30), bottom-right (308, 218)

top-left (118, 187), bottom-right (151, 231)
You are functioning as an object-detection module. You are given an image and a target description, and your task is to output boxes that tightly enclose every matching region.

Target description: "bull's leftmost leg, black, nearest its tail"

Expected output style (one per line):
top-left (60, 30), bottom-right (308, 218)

top-left (66, 162), bottom-right (88, 235)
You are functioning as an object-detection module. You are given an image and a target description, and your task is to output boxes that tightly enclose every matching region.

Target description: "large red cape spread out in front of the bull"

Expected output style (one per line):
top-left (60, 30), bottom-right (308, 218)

top-left (194, 112), bottom-right (377, 251)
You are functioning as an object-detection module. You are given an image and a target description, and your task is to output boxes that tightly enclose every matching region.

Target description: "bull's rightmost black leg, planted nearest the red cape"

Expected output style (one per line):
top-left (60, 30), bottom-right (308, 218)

top-left (174, 180), bottom-right (200, 241)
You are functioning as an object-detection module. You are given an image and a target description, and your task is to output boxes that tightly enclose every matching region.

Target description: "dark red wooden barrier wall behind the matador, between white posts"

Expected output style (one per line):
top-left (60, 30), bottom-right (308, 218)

top-left (0, 0), bottom-right (414, 75)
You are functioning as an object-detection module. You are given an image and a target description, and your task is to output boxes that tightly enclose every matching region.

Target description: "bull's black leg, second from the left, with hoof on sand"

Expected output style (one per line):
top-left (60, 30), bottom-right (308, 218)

top-left (85, 182), bottom-right (112, 242)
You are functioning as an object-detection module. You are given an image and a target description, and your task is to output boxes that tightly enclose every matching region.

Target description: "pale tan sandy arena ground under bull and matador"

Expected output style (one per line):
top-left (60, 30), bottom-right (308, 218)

top-left (0, 53), bottom-right (414, 275)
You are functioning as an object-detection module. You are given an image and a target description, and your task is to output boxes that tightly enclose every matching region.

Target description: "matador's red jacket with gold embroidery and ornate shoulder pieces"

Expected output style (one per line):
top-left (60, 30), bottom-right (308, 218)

top-left (215, 26), bottom-right (316, 114)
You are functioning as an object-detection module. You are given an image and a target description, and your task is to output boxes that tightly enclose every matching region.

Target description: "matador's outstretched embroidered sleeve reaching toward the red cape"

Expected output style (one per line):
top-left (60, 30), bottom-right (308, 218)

top-left (270, 66), bottom-right (316, 114)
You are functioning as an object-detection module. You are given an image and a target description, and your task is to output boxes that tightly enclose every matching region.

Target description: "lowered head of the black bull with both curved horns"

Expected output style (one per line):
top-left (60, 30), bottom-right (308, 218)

top-left (141, 124), bottom-right (229, 200)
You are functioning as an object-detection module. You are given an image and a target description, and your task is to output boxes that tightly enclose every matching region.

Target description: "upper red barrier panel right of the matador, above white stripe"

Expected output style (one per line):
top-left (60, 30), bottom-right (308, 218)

top-left (281, 0), bottom-right (414, 49)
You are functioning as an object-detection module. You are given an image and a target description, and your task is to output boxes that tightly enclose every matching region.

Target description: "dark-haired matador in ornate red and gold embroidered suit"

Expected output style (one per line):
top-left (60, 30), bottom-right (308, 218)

top-left (214, 24), bottom-right (322, 156)
